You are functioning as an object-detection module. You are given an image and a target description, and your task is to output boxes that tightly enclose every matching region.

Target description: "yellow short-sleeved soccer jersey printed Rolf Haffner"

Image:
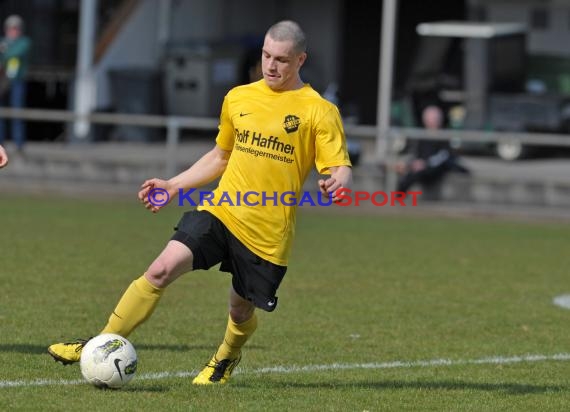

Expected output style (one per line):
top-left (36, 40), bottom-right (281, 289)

top-left (198, 80), bottom-right (350, 266)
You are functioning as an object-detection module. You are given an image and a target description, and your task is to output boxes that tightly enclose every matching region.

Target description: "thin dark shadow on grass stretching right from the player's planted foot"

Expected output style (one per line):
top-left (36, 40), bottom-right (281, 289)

top-left (234, 379), bottom-right (570, 395)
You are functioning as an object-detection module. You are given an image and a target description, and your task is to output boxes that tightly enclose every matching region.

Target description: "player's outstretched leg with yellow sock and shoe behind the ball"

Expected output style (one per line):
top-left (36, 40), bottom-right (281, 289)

top-left (48, 240), bottom-right (193, 365)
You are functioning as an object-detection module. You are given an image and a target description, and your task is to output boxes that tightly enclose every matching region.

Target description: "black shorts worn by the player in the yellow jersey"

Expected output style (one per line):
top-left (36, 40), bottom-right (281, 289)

top-left (172, 210), bottom-right (287, 312)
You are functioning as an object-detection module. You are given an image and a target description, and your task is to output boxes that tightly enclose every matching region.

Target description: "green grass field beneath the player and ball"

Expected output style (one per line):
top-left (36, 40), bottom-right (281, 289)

top-left (0, 195), bottom-right (570, 411)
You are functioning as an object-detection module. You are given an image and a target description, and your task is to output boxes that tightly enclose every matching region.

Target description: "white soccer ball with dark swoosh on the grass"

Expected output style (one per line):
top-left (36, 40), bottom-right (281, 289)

top-left (79, 333), bottom-right (137, 389)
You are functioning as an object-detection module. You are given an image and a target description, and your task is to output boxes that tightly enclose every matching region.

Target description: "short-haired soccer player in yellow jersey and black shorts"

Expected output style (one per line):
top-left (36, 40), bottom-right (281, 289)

top-left (48, 21), bottom-right (352, 385)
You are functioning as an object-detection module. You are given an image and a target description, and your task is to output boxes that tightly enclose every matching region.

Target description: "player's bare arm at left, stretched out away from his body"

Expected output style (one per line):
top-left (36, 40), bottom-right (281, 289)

top-left (139, 145), bottom-right (231, 212)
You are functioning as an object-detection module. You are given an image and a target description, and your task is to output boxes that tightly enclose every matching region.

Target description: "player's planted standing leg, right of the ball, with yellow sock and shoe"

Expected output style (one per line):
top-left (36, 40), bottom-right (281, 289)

top-left (192, 287), bottom-right (257, 385)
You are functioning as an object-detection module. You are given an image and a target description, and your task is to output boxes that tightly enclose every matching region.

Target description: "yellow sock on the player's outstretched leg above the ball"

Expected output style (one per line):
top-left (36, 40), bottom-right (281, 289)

top-left (101, 275), bottom-right (164, 338)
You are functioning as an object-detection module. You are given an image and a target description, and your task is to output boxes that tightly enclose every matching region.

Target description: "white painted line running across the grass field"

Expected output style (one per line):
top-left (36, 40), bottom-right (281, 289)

top-left (0, 353), bottom-right (570, 388)
